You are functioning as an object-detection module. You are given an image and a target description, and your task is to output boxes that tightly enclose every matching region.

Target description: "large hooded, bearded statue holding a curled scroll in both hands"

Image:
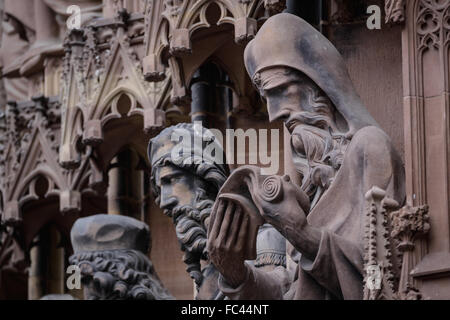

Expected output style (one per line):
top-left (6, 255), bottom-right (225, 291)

top-left (208, 13), bottom-right (405, 299)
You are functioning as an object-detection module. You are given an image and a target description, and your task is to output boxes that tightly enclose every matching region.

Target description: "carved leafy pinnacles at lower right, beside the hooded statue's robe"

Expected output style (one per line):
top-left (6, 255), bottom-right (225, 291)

top-left (364, 187), bottom-right (430, 300)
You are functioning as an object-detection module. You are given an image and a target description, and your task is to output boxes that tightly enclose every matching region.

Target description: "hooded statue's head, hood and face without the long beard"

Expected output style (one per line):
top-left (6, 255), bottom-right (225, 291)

top-left (244, 13), bottom-right (377, 138)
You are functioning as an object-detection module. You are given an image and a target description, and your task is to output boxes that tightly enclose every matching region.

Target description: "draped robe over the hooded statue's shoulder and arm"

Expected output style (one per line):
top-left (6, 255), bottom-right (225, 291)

top-left (219, 126), bottom-right (405, 300)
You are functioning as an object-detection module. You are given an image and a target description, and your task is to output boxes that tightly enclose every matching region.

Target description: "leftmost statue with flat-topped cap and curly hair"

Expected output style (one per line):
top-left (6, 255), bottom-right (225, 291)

top-left (70, 214), bottom-right (174, 300)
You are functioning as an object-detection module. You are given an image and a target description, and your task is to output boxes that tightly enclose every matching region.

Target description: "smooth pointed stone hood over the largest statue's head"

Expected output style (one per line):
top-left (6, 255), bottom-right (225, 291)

top-left (244, 13), bottom-right (378, 137)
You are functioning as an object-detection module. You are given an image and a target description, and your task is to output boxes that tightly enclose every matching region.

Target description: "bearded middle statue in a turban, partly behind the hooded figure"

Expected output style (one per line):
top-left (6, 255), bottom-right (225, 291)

top-left (149, 123), bottom-right (286, 300)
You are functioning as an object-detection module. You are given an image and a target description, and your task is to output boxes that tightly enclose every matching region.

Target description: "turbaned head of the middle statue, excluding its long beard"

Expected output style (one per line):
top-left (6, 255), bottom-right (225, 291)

top-left (148, 123), bottom-right (228, 218)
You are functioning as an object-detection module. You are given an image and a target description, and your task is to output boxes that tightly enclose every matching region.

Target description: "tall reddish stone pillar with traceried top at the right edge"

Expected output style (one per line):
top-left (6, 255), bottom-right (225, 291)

top-left (402, 0), bottom-right (450, 299)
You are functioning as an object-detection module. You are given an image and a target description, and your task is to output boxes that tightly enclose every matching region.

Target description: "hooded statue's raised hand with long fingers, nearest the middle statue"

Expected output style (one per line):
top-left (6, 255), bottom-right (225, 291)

top-left (208, 200), bottom-right (250, 288)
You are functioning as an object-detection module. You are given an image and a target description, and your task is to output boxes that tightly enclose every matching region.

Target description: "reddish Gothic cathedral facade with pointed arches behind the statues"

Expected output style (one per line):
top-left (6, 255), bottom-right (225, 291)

top-left (0, 0), bottom-right (450, 300)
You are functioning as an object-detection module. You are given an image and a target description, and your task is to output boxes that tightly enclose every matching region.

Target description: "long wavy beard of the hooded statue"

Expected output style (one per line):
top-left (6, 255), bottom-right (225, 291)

top-left (291, 112), bottom-right (348, 209)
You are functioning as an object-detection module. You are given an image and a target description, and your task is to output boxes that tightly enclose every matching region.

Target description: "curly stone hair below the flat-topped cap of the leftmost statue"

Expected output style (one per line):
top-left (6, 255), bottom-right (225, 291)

top-left (69, 250), bottom-right (174, 300)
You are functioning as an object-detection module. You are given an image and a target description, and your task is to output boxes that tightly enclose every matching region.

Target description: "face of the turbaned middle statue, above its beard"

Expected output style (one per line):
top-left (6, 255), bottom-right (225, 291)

top-left (155, 165), bottom-right (207, 216)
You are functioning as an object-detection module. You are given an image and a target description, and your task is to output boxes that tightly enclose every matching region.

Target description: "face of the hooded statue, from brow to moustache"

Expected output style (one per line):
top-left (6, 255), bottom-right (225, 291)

top-left (260, 67), bottom-right (330, 133)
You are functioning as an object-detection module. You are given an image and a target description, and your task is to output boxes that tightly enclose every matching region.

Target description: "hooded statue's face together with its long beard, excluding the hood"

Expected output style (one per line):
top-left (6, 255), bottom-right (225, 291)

top-left (258, 67), bottom-right (344, 199)
